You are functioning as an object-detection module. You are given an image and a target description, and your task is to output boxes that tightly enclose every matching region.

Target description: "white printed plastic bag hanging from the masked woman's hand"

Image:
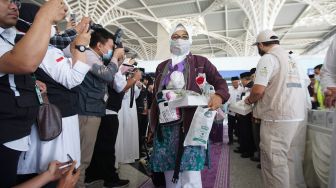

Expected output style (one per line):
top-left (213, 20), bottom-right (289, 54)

top-left (183, 106), bottom-right (216, 148)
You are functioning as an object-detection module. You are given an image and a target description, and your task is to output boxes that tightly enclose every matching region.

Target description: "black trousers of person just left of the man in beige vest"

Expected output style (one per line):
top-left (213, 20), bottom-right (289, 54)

top-left (238, 113), bottom-right (255, 153)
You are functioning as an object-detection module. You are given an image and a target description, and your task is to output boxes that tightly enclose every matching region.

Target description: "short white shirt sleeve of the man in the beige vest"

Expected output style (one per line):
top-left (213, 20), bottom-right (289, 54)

top-left (254, 54), bottom-right (280, 87)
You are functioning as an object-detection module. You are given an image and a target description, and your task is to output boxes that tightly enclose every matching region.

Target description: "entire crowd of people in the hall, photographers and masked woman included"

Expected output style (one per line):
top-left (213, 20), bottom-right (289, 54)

top-left (0, 0), bottom-right (336, 188)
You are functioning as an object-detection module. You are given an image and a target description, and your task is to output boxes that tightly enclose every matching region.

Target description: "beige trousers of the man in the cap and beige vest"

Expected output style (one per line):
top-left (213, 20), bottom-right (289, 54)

top-left (260, 121), bottom-right (303, 188)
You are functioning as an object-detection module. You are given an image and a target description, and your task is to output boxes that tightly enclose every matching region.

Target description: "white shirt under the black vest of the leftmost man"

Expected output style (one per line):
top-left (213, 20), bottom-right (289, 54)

top-left (0, 27), bottom-right (29, 151)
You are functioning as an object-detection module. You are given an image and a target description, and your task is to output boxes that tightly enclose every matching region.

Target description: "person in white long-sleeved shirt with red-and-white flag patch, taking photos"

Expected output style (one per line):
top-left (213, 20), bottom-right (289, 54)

top-left (16, 3), bottom-right (91, 179)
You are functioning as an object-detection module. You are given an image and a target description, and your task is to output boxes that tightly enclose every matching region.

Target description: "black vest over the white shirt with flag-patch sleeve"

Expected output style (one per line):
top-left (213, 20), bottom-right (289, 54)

top-left (35, 68), bottom-right (78, 117)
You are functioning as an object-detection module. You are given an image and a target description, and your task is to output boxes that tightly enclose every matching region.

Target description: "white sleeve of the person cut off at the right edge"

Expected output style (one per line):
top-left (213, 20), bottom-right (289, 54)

top-left (321, 37), bottom-right (336, 88)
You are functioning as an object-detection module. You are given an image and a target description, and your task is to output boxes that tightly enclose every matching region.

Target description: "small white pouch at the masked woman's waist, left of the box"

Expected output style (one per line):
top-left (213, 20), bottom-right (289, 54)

top-left (158, 102), bottom-right (180, 123)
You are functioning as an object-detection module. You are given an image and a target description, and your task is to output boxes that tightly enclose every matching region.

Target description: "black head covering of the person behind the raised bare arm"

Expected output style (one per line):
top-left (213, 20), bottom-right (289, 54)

top-left (15, 3), bottom-right (40, 33)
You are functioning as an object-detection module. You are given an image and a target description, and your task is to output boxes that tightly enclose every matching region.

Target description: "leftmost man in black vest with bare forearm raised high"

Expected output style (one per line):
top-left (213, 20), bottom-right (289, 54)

top-left (0, 0), bottom-right (67, 187)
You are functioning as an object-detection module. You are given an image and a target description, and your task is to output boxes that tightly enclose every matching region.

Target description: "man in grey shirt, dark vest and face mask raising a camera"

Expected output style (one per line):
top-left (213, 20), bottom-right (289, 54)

top-left (74, 28), bottom-right (124, 187)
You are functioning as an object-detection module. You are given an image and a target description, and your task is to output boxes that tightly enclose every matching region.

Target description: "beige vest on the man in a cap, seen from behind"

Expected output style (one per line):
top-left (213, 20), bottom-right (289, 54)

top-left (254, 46), bottom-right (306, 120)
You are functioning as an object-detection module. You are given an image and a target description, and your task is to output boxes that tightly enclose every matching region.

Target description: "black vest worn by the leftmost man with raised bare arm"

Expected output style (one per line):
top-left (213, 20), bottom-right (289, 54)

top-left (0, 74), bottom-right (39, 144)
